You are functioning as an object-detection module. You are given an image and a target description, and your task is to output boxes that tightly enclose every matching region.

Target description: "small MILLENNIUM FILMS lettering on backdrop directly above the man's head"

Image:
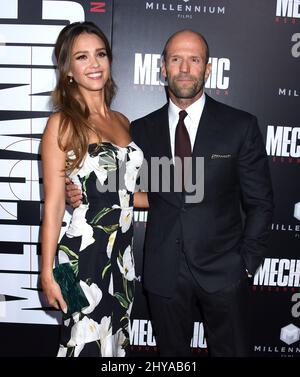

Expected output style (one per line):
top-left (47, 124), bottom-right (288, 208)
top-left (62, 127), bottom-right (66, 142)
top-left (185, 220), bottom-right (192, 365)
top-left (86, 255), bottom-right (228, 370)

top-left (145, 0), bottom-right (225, 19)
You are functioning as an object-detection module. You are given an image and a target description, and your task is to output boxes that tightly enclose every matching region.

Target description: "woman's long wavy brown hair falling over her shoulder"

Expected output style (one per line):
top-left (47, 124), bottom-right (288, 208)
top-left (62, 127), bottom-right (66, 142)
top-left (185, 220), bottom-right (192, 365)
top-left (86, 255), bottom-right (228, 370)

top-left (52, 21), bottom-right (116, 171)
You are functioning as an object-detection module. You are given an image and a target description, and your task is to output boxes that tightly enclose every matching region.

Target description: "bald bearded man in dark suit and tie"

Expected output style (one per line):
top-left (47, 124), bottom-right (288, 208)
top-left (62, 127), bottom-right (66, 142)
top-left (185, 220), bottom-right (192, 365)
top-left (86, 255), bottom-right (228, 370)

top-left (67, 30), bottom-right (273, 357)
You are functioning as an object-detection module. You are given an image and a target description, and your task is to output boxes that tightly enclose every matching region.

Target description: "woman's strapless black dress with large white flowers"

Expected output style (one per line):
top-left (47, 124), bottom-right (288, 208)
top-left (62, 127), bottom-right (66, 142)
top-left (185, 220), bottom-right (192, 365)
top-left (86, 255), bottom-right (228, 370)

top-left (57, 142), bottom-right (143, 357)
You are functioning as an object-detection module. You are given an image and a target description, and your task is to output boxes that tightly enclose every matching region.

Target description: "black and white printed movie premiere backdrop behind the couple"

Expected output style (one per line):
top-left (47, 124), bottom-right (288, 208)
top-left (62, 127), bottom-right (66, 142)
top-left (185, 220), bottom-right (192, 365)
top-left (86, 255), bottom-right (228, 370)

top-left (0, 0), bottom-right (300, 357)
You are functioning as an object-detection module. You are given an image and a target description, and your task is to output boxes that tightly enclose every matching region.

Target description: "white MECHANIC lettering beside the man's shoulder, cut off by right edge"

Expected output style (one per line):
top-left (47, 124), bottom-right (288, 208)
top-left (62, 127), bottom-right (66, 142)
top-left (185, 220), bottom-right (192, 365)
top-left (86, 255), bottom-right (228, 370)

top-left (266, 125), bottom-right (300, 164)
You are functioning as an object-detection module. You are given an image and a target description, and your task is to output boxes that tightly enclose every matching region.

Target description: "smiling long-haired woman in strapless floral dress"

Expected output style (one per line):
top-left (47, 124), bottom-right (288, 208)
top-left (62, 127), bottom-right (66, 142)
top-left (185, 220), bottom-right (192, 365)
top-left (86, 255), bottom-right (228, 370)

top-left (41, 22), bottom-right (143, 357)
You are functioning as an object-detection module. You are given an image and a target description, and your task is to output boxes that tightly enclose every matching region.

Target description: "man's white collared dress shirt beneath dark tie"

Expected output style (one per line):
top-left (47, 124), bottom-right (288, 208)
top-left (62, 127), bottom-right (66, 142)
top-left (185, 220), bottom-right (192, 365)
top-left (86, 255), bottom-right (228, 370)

top-left (168, 93), bottom-right (205, 160)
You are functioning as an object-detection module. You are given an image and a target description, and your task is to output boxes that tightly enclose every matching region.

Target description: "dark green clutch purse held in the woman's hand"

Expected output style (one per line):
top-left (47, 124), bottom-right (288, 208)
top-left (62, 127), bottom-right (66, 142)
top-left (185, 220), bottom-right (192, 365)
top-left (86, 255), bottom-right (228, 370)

top-left (53, 263), bottom-right (90, 319)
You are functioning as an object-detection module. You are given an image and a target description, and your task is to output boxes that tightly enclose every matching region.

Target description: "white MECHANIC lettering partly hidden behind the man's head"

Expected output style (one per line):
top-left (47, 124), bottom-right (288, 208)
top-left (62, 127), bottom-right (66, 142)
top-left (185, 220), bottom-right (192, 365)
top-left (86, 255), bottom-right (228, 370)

top-left (133, 52), bottom-right (230, 96)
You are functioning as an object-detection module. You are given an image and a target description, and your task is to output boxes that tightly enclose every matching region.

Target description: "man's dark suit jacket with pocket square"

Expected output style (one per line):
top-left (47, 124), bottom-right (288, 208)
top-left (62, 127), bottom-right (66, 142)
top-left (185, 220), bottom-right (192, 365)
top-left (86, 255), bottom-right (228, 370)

top-left (131, 95), bottom-right (273, 297)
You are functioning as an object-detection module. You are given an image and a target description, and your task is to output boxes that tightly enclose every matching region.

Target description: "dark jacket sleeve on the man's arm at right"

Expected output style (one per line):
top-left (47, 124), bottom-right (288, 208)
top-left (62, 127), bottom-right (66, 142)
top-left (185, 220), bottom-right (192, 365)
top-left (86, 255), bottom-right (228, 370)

top-left (238, 117), bottom-right (273, 274)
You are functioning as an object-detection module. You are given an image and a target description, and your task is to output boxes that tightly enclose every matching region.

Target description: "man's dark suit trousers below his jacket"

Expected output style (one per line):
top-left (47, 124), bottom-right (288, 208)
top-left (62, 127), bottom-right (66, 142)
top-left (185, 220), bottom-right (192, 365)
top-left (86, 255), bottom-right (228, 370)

top-left (148, 253), bottom-right (249, 357)
